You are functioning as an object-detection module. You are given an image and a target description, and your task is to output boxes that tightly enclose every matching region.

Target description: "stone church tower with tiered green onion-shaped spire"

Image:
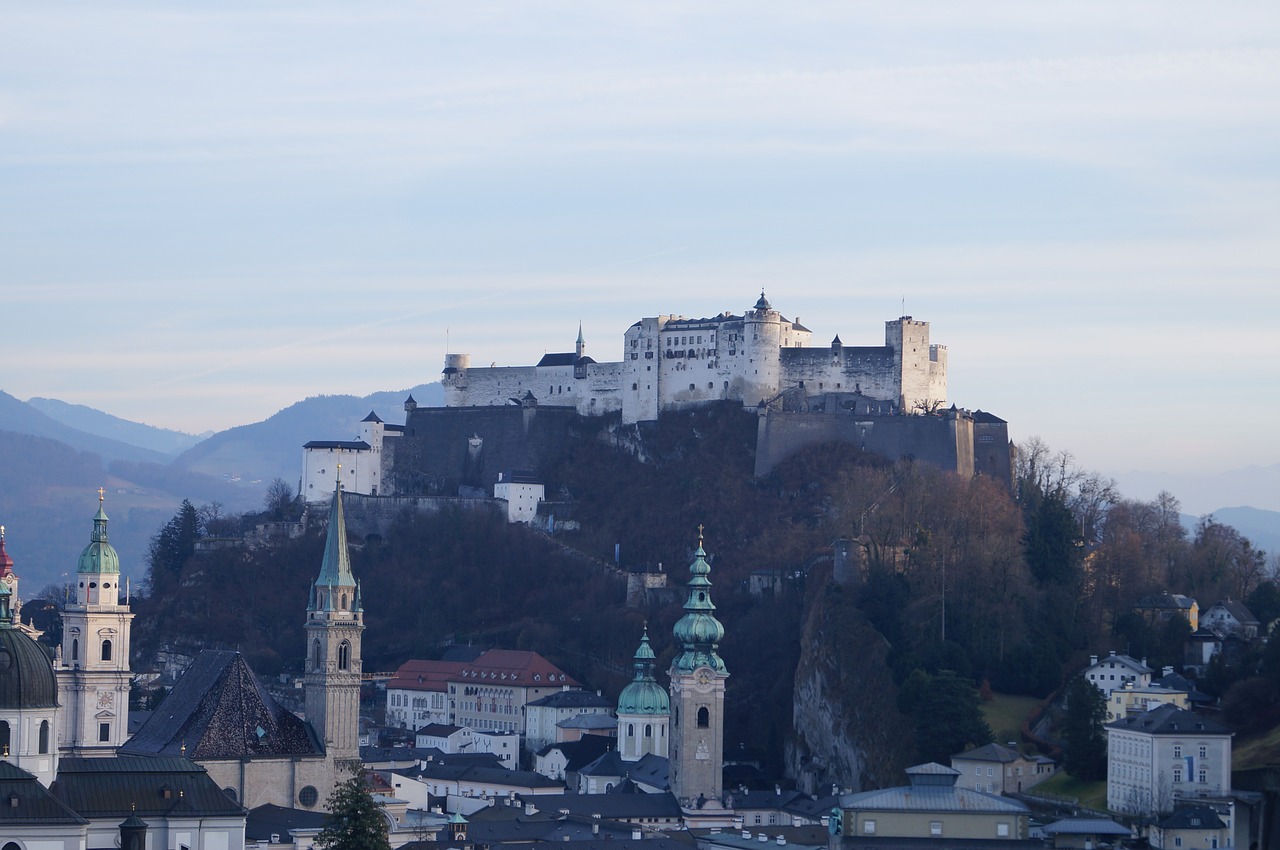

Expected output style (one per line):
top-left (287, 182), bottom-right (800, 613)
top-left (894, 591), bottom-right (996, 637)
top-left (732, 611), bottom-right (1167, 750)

top-left (669, 527), bottom-right (728, 809)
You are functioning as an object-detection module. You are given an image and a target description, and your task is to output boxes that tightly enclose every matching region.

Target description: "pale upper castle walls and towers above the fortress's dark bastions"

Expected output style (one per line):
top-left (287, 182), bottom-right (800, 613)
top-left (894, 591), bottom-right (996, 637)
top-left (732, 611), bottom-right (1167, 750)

top-left (440, 292), bottom-right (947, 425)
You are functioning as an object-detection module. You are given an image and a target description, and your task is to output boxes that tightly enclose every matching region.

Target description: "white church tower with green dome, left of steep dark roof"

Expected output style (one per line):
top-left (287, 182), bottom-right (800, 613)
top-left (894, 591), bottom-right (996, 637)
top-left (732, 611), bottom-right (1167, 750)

top-left (56, 488), bottom-right (133, 755)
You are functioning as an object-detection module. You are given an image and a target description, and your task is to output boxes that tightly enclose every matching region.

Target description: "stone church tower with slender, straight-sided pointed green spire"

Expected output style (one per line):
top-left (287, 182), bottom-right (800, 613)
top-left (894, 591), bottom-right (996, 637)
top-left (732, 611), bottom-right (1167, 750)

top-left (303, 466), bottom-right (365, 768)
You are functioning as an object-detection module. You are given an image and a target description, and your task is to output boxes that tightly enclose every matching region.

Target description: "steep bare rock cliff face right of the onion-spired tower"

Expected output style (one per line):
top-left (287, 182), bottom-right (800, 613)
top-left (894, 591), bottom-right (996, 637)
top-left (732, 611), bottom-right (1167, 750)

top-left (786, 584), bottom-right (913, 796)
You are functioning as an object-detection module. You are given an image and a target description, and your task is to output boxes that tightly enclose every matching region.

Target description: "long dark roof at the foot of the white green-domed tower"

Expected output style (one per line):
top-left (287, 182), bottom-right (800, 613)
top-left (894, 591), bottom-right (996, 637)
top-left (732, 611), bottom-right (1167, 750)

top-left (49, 755), bottom-right (244, 819)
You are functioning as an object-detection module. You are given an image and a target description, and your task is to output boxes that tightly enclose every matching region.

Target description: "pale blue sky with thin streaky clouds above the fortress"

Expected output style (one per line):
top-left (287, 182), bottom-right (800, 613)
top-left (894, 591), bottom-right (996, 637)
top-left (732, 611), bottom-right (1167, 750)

top-left (0, 0), bottom-right (1280, 483)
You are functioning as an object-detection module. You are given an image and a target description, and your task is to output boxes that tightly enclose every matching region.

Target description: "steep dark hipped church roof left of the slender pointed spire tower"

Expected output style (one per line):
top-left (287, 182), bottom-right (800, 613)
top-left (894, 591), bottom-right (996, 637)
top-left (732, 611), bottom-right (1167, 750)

top-left (120, 649), bottom-right (324, 759)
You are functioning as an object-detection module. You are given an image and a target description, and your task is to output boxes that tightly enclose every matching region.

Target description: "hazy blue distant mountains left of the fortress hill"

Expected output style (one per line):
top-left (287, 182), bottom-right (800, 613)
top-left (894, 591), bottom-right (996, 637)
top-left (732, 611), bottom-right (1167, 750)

top-left (0, 384), bottom-right (444, 597)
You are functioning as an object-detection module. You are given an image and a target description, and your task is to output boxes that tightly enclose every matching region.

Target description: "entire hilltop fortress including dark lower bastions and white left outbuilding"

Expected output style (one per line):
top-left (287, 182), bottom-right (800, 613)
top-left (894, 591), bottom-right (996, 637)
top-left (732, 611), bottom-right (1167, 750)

top-left (302, 292), bottom-right (1012, 499)
